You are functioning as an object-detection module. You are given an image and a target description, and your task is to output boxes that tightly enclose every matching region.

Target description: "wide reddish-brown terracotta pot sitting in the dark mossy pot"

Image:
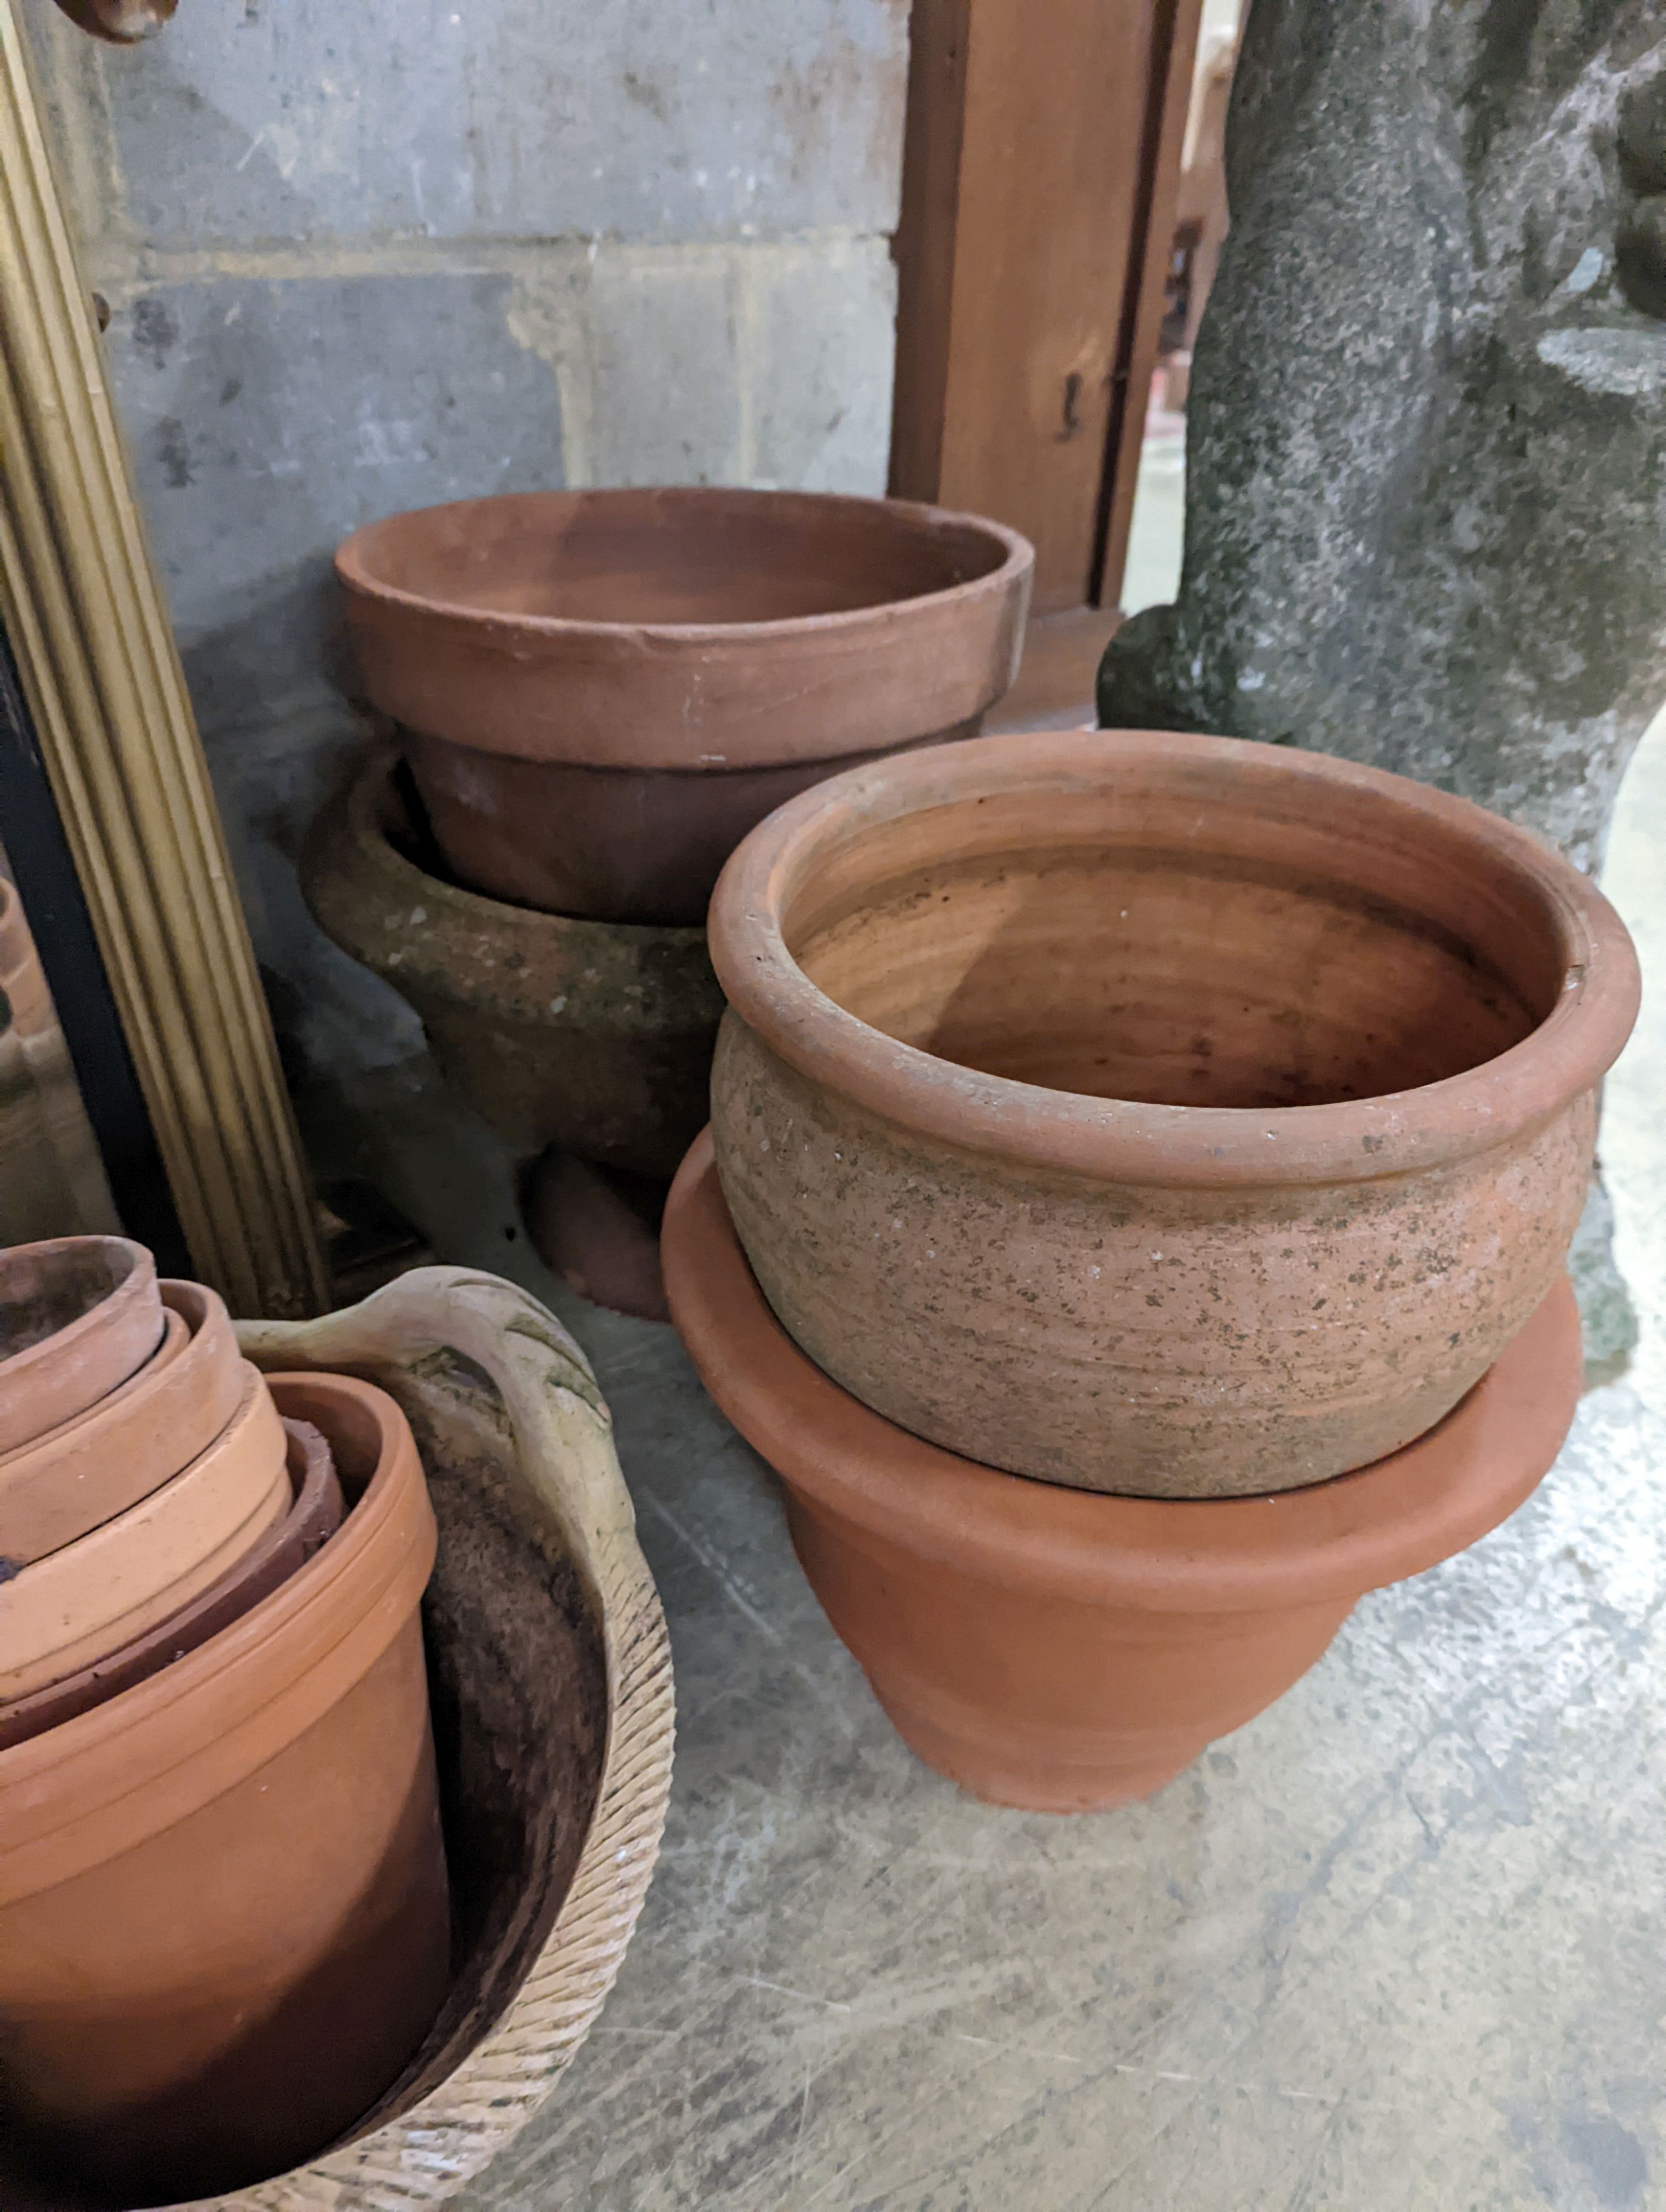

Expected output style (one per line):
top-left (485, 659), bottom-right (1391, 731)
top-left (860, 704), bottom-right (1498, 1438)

top-left (337, 486), bottom-right (1036, 924)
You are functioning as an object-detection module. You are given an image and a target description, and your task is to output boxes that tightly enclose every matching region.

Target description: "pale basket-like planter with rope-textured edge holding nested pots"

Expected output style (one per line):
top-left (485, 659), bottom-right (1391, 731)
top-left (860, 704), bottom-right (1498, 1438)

top-left (179, 1268), bottom-right (673, 2212)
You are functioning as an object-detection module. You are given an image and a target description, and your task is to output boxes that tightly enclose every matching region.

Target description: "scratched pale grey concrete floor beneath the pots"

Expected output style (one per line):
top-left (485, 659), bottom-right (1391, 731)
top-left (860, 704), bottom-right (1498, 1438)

top-left (298, 707), bottom-right (1666, 2212)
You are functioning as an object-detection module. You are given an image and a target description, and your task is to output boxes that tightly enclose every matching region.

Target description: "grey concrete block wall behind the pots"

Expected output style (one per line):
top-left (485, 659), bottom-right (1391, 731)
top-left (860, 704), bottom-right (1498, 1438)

top-left (27, 0), bottom-right (907, 1068)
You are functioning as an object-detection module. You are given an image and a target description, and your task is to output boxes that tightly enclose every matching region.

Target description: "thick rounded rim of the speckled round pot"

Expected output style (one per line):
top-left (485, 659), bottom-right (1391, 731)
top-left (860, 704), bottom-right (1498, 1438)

top-left (708, 730), bottom-right (1642, 1188)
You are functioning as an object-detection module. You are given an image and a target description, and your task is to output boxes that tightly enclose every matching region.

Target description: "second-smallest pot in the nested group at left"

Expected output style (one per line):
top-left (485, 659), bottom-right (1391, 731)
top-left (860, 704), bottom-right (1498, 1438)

top-left (0, 1281), bottom-right (245, 1566)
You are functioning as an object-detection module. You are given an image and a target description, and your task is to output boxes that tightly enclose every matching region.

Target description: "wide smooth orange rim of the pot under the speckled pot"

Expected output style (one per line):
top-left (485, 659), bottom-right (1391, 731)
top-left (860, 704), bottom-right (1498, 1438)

top-left (661, 1130), bottom-right (1584, 1612)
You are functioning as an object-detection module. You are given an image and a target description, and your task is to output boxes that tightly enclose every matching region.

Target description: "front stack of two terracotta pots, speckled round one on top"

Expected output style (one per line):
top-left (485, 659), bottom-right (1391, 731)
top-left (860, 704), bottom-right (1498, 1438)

top-left (666, 732), bottom-right (1637, 1809)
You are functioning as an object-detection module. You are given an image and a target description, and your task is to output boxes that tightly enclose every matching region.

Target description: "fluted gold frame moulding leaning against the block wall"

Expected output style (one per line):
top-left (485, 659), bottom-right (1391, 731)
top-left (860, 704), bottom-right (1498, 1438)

top-left (0, 0), bottom-right (328, 1316)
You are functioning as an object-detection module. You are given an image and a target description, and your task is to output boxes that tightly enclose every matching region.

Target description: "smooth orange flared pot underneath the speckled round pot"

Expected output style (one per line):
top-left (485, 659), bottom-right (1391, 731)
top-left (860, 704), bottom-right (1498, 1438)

top-left (664, 1139), bottom-right (1582, 1812)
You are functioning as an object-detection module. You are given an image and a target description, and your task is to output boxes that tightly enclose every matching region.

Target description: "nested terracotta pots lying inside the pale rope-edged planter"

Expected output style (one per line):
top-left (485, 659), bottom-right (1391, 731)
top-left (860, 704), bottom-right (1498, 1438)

top-left (0, 1236), bottom-right (449, 2203)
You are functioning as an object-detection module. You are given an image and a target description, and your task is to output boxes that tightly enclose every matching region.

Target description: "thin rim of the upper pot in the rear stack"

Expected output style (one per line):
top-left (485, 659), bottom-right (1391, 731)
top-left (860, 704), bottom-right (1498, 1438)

top-left (337, 484), bottom-right (1036, 648)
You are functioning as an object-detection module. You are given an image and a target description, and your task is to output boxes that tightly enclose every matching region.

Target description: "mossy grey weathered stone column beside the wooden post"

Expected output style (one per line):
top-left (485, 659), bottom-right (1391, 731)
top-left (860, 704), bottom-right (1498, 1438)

top-left (1100, 0), bottom-right (1666, 867)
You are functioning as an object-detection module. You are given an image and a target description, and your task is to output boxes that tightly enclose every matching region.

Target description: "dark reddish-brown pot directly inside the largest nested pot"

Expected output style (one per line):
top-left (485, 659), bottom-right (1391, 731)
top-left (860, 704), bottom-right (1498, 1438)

top-left (0, 1406), bottom-right (343, 1750)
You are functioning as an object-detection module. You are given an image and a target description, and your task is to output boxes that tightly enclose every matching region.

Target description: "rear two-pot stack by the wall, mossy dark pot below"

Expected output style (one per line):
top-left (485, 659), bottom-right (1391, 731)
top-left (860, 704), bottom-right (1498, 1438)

top-left (303, 489), bottom-right (1033, 1312)
